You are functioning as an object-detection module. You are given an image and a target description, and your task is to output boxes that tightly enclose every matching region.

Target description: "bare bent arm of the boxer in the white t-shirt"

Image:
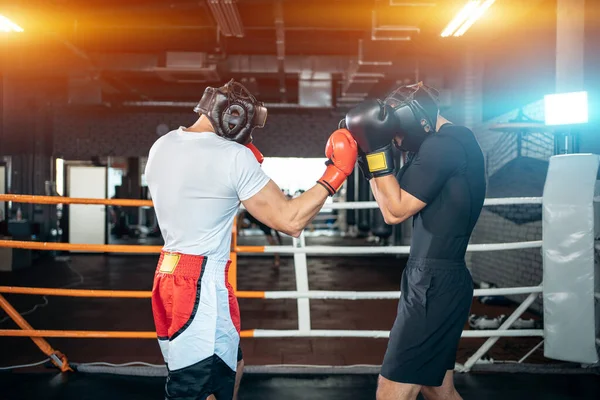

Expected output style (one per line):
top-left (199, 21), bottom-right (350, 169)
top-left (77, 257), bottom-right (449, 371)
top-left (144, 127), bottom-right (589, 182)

top-left (243, 180), bottom-right (329, 237)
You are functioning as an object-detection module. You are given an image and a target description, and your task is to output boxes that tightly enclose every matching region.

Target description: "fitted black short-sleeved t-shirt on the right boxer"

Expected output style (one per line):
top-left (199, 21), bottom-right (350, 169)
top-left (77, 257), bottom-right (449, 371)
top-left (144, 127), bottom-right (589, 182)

top-left (397, 124), bottom-right (486, 260)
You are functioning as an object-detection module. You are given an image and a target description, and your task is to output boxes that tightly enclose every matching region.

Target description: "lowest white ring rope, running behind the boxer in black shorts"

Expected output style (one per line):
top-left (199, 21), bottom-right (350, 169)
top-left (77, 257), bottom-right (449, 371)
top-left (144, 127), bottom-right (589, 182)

top-left (252, 329), bottom-right (544, 339)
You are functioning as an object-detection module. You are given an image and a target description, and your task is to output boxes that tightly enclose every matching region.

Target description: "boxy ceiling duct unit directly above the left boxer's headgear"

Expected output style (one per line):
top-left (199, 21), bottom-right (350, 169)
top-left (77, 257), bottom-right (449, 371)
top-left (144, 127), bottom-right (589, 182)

top-left (153, 52), bottom-right (221, 83)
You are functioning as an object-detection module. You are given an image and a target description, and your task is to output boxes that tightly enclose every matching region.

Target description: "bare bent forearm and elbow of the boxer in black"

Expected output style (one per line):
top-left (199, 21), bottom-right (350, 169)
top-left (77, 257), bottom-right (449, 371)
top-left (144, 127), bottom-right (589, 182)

top-left (371, 175), bottom-right (427, 225)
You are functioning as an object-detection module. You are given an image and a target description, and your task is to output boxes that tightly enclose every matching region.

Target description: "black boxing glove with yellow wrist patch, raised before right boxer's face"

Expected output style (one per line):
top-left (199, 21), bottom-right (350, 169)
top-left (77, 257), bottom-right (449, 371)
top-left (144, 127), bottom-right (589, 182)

top-left (346, 100), bottom-right (400, 179)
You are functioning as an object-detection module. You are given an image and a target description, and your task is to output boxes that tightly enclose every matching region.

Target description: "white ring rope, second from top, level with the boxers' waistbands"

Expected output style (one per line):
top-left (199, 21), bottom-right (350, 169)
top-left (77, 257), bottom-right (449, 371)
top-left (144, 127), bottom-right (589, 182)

top-left (237, 240), bottom-right (542, 255)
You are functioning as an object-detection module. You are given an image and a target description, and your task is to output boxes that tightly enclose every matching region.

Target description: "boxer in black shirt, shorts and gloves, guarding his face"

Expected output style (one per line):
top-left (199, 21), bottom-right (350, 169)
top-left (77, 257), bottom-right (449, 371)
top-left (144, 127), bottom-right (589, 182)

top-left (345, 83), bottom-right (486, 400)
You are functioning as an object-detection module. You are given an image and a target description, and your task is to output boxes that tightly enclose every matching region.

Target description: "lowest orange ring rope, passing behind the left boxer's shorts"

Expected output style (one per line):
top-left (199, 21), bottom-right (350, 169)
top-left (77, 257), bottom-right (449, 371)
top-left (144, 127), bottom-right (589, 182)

top-left (0, 329), bottom-right (254, 339)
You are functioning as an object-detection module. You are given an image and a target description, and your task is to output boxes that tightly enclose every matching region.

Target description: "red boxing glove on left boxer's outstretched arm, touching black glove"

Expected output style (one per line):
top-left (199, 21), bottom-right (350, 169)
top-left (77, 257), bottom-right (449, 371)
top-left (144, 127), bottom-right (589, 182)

top-left (317, 129), bottom-right (358, 196)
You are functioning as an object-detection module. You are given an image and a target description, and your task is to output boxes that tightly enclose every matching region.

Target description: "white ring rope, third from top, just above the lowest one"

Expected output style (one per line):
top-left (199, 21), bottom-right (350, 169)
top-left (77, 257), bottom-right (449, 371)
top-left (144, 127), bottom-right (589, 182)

top-left (264, 286), bottom-right (543, 300)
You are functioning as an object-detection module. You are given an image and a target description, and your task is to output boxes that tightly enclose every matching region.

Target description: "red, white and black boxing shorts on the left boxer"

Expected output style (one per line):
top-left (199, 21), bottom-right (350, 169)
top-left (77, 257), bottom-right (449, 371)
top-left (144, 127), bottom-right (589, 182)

top-left (152, 252), bottom-right (241, 399)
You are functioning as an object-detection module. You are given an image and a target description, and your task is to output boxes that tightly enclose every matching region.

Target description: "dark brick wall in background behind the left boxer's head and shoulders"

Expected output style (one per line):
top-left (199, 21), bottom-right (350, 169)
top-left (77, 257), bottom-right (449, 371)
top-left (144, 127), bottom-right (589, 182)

top-left (54, 108), bottom-right (341, 160)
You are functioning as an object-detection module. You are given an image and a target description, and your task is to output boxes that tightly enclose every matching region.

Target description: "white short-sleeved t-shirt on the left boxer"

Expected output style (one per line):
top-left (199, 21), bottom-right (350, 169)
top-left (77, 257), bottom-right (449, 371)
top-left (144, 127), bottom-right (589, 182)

top-left (145, 128), bottom-right (269, 260)
